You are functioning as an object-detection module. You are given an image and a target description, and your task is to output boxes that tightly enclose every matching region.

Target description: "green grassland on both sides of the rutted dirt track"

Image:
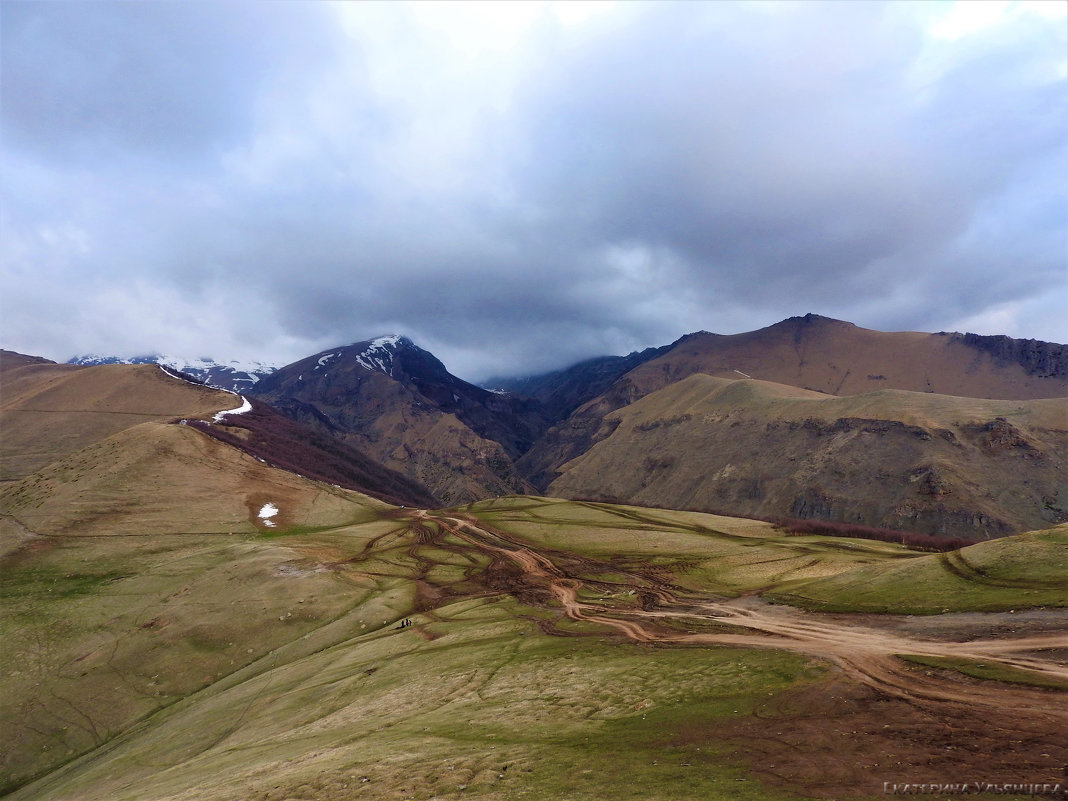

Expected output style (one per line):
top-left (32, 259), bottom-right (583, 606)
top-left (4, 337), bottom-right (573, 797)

top-left (0, 493), bottom-right (1064, 801)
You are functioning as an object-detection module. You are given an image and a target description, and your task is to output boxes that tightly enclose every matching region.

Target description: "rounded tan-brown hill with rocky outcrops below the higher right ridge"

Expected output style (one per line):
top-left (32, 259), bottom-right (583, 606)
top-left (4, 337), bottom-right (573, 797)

top-left (550, 375), bottom-right (1068, 537)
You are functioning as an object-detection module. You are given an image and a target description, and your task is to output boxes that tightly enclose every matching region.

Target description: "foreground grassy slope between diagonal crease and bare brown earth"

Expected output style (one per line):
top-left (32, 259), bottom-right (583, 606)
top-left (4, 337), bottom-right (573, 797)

top-left (8, 601), bottom-right (819, 801)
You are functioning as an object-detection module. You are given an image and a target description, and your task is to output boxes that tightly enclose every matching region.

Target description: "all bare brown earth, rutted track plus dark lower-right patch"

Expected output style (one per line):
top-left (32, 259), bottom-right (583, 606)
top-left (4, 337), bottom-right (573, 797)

top-left (411, 512), bottom-right (1068, 798)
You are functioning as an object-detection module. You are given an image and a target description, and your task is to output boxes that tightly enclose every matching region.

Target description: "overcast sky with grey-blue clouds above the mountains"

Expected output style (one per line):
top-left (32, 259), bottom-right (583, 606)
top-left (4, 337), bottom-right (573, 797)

top-left (0, 0), bottom-right (1068, 380)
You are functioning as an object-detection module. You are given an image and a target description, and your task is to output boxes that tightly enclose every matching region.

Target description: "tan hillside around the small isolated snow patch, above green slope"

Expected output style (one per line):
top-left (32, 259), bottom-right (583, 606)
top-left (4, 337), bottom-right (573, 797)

top-left (0, 422), bottom-right (387, 536)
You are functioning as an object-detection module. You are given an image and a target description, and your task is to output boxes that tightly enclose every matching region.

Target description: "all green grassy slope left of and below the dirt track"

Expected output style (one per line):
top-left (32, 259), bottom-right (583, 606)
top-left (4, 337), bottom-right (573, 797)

top-left (0, 501), bottom-right (822, 801)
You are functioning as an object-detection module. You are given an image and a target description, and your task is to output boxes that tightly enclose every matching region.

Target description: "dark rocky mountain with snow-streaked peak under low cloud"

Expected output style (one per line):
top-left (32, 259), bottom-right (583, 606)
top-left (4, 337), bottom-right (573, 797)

top-left (256, 336), bottom-right (545, 504)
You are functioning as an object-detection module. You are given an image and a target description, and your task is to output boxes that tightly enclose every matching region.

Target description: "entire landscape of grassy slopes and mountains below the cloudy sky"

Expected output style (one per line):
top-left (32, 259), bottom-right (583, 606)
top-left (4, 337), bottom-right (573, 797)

top-left (0, 317), bottom-right (1068, 801)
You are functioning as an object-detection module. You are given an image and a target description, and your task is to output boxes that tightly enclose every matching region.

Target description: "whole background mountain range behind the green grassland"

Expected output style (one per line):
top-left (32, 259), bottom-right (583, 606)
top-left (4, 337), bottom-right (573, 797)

top-left (31, 314), bottom-right (1068, 538)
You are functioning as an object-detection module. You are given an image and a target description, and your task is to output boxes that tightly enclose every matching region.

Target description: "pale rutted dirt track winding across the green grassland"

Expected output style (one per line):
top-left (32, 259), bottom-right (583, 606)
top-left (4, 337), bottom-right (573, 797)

top-left (414, 513), bottom-right (1068, 729)
